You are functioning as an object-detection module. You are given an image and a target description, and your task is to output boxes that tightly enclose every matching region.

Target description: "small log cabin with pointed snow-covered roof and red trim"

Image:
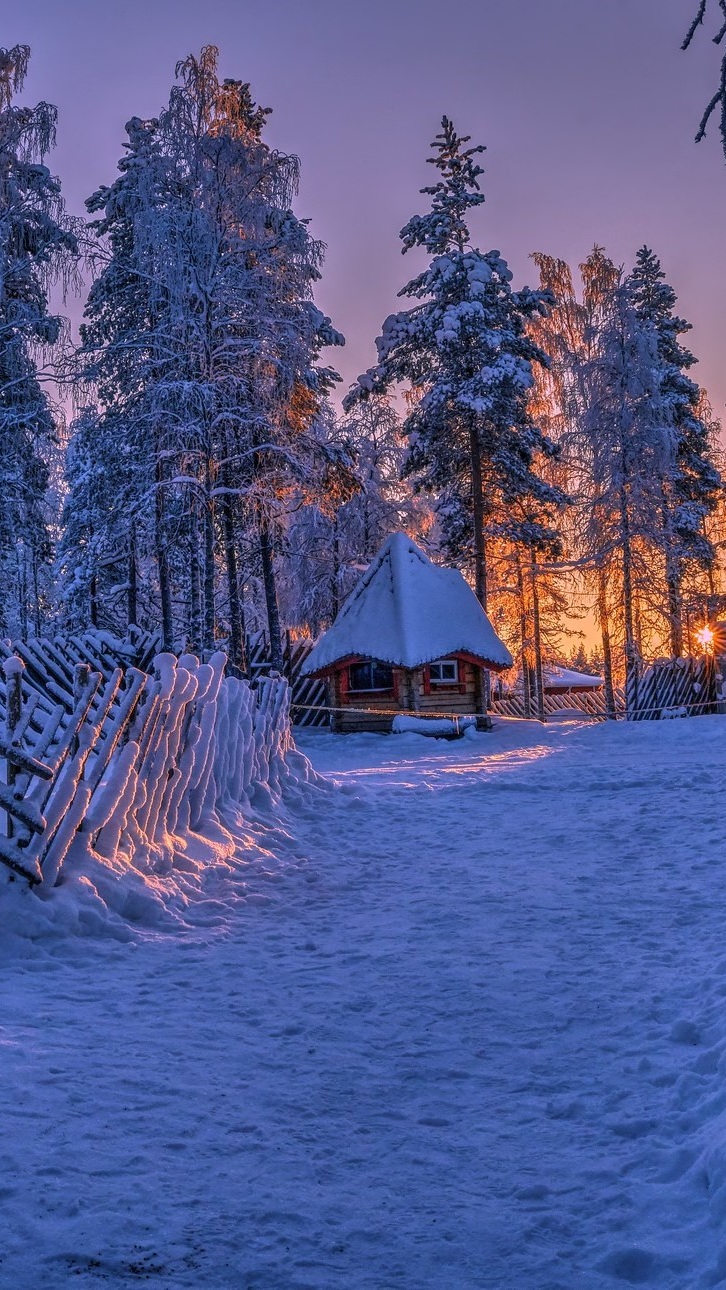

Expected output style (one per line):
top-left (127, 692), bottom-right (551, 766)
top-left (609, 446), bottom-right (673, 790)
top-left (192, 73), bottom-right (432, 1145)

top-left (303, 533), bottom-right (512, 731)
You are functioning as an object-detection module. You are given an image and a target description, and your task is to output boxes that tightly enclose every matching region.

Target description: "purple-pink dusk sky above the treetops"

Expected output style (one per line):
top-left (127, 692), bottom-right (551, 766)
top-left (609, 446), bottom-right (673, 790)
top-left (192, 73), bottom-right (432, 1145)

top-left (9, 0), bottom-right (726, 419)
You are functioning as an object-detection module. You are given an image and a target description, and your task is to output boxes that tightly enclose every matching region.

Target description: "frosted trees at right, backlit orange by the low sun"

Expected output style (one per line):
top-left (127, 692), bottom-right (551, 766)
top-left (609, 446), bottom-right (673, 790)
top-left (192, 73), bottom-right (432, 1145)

top-left (535, 248), bottom-right (721, 707)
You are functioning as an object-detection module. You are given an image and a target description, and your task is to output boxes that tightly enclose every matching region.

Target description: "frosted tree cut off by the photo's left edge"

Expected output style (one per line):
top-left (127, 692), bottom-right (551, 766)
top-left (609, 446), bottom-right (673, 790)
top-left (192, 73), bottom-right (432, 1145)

top-left (0, 45), bottom-right (77, 636)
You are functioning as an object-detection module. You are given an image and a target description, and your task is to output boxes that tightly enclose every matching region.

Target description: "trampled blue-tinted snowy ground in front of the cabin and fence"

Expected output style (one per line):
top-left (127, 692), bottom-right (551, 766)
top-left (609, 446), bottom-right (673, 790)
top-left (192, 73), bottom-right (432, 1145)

top-left (0, 717), bottom-right (726, 1290)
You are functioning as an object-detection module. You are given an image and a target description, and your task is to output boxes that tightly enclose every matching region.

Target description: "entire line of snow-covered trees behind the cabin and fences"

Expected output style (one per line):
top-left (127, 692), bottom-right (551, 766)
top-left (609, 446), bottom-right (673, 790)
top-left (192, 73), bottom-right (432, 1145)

top-left (0, 46), bottom-right (723, 703)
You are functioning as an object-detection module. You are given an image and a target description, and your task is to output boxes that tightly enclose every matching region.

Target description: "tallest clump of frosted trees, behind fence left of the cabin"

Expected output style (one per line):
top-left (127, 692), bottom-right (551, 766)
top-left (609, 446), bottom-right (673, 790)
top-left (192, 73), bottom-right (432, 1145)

top-left (71, 46), bottom-right (342, 667)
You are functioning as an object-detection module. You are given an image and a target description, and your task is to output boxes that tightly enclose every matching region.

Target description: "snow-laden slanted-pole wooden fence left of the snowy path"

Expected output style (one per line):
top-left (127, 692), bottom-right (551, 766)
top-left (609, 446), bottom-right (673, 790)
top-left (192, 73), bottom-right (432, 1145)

top-left (0, 633), bottom-right (309, 885)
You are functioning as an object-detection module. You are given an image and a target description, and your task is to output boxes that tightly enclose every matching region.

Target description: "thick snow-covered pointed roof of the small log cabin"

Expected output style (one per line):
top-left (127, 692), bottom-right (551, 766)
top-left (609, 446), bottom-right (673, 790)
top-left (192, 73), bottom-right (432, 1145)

top-left (303, 533), bottom-right (512, 675)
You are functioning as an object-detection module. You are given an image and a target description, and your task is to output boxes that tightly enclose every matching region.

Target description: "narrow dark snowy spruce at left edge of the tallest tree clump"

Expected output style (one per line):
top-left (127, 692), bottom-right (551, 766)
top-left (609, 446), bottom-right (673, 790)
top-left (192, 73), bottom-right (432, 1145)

top-left (76, 117), bottom-right (167, 648)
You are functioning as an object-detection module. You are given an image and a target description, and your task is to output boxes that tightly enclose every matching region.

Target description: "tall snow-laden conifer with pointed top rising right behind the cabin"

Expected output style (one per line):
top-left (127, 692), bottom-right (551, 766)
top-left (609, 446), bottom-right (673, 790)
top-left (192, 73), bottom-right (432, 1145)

top-left (346, 117), bottom-right (564, 619)
